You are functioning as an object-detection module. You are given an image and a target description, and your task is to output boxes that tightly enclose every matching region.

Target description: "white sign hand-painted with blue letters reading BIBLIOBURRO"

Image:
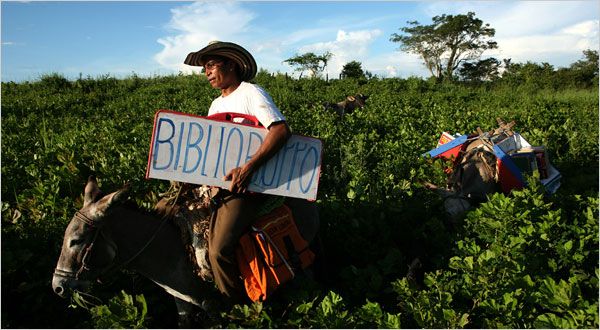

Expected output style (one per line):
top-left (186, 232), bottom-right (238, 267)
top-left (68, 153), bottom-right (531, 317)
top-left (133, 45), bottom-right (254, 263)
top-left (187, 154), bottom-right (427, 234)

top-left (146, 110), bottom-right (323, 200)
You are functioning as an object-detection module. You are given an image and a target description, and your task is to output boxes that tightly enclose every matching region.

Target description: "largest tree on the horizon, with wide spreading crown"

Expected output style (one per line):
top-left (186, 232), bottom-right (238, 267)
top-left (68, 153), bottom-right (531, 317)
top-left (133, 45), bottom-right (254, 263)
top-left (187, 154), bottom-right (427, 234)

top-left (390, 12), bottom-right (498, 80)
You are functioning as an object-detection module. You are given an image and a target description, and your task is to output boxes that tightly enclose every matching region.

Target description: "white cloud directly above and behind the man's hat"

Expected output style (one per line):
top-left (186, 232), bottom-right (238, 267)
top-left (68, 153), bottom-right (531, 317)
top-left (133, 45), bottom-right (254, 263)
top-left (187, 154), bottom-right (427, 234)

top-left (154, 1), bottom-right (255, 73)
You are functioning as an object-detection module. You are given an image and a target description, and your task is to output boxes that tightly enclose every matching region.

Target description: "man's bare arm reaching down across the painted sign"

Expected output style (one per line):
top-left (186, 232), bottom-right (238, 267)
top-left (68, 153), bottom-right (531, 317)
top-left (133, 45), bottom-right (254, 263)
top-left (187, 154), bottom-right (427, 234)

top-left (223, 121), bottom-right (292, 193)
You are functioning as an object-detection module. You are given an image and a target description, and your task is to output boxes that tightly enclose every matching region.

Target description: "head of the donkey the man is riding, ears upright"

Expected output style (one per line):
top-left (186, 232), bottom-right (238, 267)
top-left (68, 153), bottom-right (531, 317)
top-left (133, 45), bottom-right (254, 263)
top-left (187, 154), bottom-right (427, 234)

top-left (52, 175), bottom-right (130, 297)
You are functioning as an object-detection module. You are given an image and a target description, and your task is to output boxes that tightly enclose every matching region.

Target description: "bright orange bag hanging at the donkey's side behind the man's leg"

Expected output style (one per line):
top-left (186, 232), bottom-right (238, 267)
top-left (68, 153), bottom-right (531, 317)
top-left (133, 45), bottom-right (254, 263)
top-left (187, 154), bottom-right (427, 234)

top-left (236, 205), bottom-right (315, 301)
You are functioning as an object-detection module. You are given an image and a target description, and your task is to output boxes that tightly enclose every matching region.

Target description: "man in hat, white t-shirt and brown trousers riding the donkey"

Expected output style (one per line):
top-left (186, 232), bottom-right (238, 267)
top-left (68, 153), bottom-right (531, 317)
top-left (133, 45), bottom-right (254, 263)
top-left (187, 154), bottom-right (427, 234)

top-left (184, 41), bottom-right (291, 303)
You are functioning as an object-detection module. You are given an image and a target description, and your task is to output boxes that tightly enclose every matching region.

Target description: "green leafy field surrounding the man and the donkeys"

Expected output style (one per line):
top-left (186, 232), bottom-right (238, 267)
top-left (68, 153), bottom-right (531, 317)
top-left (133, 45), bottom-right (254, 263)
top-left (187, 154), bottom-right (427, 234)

top-left (1, 72), bottom-right (599, 328)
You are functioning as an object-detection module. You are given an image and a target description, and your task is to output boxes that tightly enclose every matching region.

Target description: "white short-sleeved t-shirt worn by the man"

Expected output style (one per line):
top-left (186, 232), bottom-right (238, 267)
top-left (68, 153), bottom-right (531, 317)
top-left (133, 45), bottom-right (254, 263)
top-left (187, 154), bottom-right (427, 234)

top-left (208, 81), bottom-right (285, 128)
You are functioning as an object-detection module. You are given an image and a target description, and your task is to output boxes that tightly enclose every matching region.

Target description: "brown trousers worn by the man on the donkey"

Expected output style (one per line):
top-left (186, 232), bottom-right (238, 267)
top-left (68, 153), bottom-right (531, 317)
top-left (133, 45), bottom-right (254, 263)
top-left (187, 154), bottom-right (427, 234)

top-left (208, 189), bottom-right (266, 303)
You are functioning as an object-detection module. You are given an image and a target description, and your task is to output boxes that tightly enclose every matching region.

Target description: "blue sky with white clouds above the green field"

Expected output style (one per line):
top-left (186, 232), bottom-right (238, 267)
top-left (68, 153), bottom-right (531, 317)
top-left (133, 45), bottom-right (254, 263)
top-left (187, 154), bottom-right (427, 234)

top-left (0, 1), bottom-right (600, 82)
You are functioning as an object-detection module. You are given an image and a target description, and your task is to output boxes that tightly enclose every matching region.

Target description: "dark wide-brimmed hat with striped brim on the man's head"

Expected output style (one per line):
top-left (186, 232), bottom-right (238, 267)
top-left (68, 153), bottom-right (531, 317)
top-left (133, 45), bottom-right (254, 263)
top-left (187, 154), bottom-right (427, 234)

top-left (183, 41), bottom-right (256, 81)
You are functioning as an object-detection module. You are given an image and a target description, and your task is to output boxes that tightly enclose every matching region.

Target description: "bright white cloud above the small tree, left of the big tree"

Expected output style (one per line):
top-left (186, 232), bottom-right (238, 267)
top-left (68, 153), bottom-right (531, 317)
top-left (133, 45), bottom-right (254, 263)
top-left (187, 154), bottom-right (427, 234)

top-left (298, 29), bottom-right (383, 78)
